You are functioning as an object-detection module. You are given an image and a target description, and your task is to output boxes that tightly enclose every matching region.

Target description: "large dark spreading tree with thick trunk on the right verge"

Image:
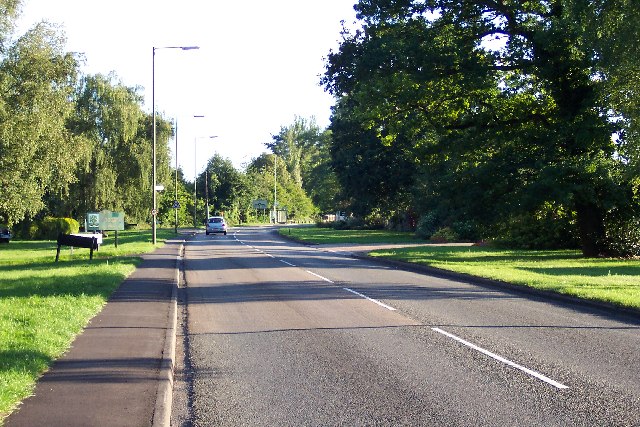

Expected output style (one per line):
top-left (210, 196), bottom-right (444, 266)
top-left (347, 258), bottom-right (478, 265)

top-left (324, 0), bottom-right (640, 256)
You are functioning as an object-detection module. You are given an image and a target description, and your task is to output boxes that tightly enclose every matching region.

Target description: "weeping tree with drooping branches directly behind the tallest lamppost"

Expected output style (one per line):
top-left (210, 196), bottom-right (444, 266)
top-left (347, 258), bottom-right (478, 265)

top-left (69, 74), bottom-right (172, 222)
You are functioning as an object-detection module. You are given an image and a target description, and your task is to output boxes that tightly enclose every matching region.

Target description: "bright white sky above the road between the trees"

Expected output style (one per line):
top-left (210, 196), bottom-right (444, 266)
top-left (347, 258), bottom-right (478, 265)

top-left (18, 0), bottom-right (355, 178)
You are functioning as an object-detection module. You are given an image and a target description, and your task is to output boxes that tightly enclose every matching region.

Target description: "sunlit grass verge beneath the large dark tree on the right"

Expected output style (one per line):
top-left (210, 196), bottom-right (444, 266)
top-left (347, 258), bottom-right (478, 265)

top-left (371, 247), bottom-right (640, 309)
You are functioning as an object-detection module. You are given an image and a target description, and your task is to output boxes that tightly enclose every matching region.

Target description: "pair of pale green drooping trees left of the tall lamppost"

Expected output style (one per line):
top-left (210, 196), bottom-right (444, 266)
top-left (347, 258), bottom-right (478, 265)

top-left (0, 0), bottom-right (172, 231)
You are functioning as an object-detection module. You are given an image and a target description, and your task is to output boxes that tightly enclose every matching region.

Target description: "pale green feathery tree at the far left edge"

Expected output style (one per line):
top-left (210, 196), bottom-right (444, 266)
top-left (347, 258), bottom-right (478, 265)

top-left (0, 22), bottom-right (83, 224)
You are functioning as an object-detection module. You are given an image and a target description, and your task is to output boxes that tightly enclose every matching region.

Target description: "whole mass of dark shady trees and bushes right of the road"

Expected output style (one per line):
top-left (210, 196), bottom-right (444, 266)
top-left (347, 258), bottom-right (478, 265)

top-left (322, 0), bottom-right (640, 256)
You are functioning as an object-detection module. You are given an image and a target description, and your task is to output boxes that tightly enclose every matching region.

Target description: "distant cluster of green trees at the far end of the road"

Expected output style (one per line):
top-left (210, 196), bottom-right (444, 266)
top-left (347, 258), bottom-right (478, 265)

top-left (170, 117), bottom-right (339, 223)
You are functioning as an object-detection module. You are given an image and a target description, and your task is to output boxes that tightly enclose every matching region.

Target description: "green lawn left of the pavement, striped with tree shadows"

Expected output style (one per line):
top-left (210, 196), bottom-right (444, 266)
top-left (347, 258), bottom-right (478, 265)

top-left (0, 230), bottom-right (174, 424)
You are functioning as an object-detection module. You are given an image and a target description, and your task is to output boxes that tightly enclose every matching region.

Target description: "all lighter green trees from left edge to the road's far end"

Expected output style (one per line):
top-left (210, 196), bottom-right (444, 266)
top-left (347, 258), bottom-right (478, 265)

top-left (0, 0), bottom-right (329, 234)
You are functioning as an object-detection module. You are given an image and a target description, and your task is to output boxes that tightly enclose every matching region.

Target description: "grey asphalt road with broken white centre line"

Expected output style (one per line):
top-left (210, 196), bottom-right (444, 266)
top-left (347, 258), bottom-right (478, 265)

top-left (172, 228), bottom-right (640, 426)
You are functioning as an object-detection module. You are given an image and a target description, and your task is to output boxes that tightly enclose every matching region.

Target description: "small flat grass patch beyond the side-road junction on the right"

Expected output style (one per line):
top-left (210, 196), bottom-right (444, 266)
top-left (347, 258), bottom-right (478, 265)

top-left (279, 227), bottom-right (424, 244)
